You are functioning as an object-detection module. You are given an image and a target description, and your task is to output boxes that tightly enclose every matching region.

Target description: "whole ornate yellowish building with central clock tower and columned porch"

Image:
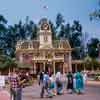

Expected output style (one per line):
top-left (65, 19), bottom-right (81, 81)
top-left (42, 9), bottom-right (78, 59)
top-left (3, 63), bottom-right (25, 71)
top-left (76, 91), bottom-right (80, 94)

top-left (16, 19), bottom-right (72, 74)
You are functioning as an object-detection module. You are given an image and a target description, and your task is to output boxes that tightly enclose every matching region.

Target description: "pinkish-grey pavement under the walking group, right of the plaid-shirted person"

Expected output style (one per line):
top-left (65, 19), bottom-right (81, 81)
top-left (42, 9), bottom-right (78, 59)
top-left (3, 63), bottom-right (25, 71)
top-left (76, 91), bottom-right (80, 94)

top-left (23, 84), bottom-right (100, 100)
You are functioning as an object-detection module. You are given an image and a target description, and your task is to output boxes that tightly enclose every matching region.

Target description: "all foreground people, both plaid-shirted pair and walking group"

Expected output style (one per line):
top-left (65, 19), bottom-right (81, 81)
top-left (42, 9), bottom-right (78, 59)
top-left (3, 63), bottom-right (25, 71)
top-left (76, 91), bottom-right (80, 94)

top-left (0, 69), bottom-right (86, 100)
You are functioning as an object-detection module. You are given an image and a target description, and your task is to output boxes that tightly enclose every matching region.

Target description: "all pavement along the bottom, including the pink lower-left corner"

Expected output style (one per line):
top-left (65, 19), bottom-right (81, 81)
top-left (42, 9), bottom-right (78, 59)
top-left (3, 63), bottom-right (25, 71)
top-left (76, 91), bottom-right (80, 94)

top-left (0, 81), bottom-right (100, 100)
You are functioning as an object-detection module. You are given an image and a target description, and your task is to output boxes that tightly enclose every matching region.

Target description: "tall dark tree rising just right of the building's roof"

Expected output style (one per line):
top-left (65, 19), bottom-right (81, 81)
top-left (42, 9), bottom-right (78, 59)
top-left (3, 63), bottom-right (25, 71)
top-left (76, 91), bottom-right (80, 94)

top-left (69, 20), bottom-right (82, 59)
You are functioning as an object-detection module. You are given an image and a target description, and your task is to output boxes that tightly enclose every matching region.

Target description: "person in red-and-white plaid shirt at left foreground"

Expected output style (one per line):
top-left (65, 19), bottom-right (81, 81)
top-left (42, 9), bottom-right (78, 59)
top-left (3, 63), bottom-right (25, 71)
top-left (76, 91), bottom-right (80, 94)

top-left (9, 69), bottom-right (24, 100)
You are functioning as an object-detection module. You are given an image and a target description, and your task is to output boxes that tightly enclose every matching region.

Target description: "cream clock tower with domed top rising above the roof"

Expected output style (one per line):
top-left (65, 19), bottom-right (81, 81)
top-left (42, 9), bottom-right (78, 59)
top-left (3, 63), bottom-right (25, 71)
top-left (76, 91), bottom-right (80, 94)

top-left (38, 19), bottom-right (52, 48)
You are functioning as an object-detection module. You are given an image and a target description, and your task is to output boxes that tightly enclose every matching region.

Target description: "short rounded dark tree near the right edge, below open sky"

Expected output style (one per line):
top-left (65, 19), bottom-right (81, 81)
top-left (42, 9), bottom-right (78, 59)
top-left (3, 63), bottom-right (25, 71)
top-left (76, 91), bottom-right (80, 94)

top-left (87, 38), bottom-right (99, 58)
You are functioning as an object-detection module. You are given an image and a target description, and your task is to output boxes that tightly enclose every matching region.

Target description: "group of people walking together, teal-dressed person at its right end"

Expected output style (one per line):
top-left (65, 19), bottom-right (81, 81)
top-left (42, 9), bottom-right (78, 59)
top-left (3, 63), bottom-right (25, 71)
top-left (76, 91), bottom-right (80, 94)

top-left (38, 71), bottom-right (85, 98)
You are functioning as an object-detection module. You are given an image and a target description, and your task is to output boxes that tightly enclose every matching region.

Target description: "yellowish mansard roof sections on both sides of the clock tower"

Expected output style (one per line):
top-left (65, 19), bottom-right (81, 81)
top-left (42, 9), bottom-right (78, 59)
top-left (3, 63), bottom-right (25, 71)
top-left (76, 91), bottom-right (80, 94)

top-left (16, 40), bottom-right (71, 50)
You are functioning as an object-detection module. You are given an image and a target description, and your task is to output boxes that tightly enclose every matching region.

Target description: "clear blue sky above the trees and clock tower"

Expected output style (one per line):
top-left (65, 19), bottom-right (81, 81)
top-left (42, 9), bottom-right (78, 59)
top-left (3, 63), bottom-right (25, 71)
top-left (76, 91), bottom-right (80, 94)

top-left (0, 0), bottom-right (100, 38)
